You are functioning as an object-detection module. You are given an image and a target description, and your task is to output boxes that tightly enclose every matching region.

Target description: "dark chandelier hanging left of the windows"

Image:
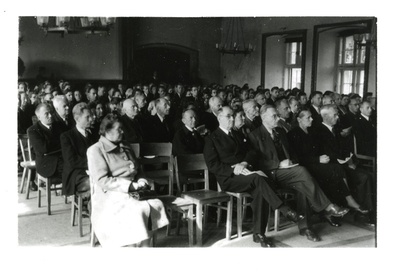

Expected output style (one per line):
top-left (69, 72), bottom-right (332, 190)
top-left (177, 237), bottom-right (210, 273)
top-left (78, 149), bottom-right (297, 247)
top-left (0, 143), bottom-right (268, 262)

top-left (215, 18), bottom-right (255, 55)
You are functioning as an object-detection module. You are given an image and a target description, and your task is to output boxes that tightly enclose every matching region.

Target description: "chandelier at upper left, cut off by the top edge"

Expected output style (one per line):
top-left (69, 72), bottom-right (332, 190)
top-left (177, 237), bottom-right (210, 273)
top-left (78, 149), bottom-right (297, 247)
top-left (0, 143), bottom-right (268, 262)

top-left (36, 16), bottom-right (116, 37)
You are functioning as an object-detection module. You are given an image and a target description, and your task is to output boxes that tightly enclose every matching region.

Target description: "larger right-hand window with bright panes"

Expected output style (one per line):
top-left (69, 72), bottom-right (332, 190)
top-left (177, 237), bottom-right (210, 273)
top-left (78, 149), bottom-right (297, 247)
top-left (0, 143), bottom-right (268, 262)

top-left (337, 35), bottom-right (365, 96)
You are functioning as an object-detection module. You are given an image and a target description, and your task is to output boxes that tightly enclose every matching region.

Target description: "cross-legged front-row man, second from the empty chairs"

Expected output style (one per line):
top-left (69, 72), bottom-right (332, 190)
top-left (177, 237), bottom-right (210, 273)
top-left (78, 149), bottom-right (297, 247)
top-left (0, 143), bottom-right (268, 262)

top-left (249, 105), bottom-right (349, 242)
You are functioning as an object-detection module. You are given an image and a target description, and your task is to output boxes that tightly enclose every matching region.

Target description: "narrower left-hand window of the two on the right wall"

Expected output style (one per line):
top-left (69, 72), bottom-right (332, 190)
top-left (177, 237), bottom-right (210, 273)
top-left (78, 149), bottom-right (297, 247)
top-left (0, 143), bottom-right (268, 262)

top-left (285, 42), bottom-right (302, 89)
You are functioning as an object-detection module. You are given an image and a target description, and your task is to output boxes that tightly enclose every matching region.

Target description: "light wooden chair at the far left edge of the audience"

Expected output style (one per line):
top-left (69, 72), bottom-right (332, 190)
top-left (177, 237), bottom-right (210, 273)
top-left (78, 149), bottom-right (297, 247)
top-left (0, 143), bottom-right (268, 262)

top-left (18, 134), bottom-right (36, 199)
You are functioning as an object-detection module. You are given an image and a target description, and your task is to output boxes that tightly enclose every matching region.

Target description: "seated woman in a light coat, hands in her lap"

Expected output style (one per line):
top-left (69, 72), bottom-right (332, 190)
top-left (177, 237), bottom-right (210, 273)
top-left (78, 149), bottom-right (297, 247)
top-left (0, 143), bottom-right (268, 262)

top-left (87, 114), bottom-right (168, 247)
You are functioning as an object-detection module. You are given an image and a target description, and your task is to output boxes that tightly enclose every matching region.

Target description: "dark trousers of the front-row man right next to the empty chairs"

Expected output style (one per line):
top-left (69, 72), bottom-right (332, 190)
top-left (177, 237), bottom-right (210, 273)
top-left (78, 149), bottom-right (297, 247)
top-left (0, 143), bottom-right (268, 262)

top-left (223, 174), bottom-right (283, 234)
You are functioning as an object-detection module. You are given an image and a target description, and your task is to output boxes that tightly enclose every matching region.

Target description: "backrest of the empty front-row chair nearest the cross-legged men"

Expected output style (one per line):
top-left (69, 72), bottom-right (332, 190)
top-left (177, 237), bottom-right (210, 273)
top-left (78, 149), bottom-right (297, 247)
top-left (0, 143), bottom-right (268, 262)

top-left (174, 154), bottom-right (210, 190)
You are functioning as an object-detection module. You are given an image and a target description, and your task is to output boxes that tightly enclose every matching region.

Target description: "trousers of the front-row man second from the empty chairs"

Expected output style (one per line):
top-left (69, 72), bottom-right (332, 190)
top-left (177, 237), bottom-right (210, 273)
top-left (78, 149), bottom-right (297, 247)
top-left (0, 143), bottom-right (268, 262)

top-left (271, 166), bottom-right (331, 229)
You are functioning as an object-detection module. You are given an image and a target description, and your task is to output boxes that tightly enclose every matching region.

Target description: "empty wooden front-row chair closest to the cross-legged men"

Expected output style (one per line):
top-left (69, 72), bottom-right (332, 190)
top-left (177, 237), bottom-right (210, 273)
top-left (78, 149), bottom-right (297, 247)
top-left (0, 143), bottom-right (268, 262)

top-left (174, 154), bottom-right (232, 246)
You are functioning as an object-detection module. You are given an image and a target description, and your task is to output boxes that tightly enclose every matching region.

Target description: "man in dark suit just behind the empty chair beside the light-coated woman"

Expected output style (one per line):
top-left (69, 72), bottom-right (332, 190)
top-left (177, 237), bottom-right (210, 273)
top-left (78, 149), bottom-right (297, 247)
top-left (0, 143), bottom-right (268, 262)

top-left (146, 98), bottom-right (174, 143)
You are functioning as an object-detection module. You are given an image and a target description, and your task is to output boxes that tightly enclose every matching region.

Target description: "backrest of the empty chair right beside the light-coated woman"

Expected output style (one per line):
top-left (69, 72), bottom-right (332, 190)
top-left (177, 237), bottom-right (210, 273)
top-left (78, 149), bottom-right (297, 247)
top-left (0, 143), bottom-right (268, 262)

top-left (138, 143), bottom-right (173, 195)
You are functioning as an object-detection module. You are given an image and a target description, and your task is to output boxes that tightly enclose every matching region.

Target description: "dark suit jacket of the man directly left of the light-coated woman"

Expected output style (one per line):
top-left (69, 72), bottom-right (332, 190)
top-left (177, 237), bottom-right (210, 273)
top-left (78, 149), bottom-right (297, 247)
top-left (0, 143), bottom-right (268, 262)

top-left (60, 127), bottom-right (96, 196)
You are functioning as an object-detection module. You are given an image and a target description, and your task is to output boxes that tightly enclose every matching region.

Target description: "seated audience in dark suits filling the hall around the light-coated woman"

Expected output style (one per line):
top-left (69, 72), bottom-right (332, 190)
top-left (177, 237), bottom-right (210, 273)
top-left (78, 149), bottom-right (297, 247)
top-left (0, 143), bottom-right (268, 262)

top-left (18, 78), bottom-right (376, 247)
